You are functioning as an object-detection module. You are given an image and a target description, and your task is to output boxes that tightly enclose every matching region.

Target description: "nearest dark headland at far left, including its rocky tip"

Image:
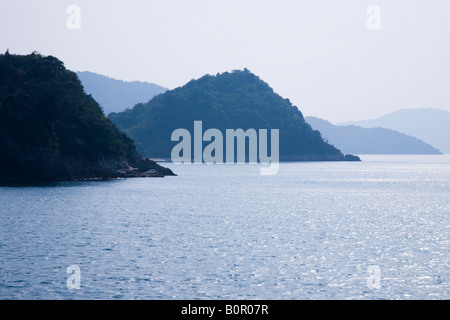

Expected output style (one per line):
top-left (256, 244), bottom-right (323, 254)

top-left (0, 52), bottom-right (174, 184)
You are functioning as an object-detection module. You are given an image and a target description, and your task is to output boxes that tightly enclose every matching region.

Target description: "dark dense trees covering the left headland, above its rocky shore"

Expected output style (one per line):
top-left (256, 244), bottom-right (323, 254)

top-left (0, 54), bottom-right (130, 157)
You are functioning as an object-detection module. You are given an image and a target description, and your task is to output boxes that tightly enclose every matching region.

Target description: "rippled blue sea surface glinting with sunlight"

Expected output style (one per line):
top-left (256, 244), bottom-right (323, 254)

top-left (0, 155), bottom-right (450, 300)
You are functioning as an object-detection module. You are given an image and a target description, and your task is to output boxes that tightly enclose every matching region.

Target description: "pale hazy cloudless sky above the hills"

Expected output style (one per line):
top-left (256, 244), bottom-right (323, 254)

top-left (0, 0), bottom-right (450, 122)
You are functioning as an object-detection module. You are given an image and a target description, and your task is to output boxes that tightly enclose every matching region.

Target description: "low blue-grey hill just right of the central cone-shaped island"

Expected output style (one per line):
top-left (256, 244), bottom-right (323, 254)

top-left (305, 117), bottom-right (441, 154)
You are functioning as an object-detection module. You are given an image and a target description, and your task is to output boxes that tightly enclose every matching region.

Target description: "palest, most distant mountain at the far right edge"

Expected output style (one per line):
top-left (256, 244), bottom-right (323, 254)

top-left (345, 108), bottom-right (450, 153)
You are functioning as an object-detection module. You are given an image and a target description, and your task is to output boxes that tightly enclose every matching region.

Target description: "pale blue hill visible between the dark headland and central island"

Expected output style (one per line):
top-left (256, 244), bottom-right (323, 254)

top-left (76, 71), bottom-right (167, 115)
